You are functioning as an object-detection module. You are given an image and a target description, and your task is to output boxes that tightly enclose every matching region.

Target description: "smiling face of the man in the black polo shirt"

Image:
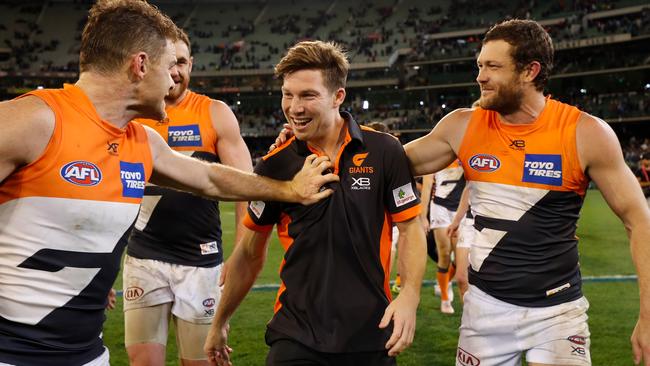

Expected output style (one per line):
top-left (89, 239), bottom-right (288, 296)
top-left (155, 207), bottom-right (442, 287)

top-left (282, 70), bottom-right (339, 141)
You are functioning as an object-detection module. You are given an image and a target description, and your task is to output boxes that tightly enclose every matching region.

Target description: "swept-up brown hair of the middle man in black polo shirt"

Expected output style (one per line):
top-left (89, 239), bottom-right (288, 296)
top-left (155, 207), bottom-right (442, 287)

top-left (275, 41), bottom-right (350, 91)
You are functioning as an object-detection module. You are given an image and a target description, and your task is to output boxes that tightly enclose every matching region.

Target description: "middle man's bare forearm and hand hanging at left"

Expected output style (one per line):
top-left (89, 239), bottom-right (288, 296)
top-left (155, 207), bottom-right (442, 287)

top-left (204, 228), bottom-right (271, 362)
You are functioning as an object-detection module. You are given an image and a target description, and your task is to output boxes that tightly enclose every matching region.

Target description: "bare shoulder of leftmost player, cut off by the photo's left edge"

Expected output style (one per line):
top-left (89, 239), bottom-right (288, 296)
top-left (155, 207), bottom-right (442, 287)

top-left (0, 96), bottom-right (55, 182)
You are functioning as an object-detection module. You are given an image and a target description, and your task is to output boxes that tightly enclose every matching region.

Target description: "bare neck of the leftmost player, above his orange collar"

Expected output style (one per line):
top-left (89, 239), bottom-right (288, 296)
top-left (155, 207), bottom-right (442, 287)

top-left (75, 72), bottom-right (137, 128)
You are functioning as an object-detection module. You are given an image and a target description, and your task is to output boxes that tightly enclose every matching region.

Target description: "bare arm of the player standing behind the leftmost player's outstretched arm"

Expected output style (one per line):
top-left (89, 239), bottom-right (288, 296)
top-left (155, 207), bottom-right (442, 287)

top-left (210, 100), bottom-right (253, 242)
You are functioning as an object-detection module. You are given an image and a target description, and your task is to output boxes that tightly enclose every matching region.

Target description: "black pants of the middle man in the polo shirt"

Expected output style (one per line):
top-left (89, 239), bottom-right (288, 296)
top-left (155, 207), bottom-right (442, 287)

top-left (266, 338), bottom-right (397, 366)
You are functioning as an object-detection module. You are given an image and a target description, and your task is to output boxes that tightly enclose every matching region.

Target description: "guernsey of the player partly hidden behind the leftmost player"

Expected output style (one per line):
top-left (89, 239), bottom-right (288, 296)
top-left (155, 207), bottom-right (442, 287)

top-left (127, 91), bottom-right (223, 267)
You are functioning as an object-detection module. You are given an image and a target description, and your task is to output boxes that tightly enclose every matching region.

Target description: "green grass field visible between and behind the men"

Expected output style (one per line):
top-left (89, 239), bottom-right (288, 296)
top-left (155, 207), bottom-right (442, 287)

top-left (104, 190), bottom-right (639, 366)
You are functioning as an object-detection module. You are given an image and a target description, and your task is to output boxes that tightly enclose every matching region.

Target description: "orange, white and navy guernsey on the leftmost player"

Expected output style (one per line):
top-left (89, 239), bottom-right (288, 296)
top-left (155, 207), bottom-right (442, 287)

top-left (0, 85), bottom-right (152, 365)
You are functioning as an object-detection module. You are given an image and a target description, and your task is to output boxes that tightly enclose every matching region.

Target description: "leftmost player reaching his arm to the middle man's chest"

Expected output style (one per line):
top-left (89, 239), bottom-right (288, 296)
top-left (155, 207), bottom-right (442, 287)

top-left (0, 0), bottom-right (337, 366)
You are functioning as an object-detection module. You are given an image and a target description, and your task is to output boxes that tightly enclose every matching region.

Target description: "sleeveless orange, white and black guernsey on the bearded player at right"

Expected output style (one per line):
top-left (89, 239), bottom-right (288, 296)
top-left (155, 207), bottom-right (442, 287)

top-left (458, 98), bottom-right (588, 307)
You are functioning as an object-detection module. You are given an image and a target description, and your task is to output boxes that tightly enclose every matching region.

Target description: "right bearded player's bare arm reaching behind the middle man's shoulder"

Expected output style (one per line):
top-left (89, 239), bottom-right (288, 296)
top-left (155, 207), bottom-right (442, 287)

top-left (404, 109), bottom-right (472, 176)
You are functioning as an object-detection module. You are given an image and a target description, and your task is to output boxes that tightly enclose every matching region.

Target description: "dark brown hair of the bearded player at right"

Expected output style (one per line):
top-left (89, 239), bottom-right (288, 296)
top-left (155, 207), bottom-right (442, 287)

top-left (483, 19), bottom-right (554, 91)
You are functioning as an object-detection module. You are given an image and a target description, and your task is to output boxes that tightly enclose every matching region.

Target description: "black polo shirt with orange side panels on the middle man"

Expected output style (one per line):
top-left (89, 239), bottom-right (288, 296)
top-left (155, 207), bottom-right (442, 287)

top-left (244, 113), bottom-right (420, 352)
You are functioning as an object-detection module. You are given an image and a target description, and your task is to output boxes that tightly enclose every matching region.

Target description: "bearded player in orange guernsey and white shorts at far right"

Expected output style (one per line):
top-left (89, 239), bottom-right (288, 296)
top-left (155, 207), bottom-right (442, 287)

top-left (406, 20), bottom-right (650, 366)
